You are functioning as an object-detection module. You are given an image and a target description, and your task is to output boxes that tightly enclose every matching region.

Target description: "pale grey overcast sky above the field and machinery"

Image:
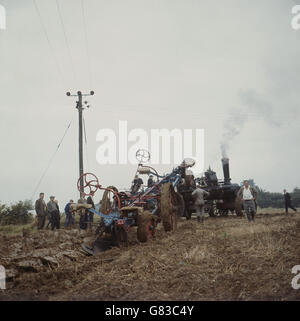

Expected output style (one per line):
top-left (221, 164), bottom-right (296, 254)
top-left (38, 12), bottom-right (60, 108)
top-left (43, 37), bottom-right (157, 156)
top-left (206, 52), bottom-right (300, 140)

top-left (0, 0), bottom-right (300, 205)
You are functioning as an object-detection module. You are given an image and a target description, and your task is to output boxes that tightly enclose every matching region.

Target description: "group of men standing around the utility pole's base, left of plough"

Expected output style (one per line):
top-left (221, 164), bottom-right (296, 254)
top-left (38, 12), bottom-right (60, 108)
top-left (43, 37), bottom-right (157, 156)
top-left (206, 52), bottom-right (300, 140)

top-left (35, 193), bottom-right (95, 231)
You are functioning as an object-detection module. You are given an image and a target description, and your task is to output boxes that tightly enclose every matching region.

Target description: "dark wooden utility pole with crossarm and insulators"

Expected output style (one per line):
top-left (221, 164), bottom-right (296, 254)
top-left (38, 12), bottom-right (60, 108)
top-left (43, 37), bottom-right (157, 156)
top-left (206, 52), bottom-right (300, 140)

top-left (67, 91), bottom-right (94, 197)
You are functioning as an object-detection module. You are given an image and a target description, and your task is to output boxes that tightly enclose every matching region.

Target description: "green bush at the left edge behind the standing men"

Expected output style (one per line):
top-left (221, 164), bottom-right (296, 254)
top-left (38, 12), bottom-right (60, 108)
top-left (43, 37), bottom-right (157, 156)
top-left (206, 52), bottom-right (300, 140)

top-left (0, 200), bottom-right (33, 225)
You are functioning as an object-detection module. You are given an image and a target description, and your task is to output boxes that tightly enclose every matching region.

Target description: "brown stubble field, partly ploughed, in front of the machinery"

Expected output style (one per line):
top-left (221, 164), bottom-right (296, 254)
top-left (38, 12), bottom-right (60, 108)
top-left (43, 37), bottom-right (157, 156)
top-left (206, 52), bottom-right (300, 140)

top-left (0, 213), bottom-right (300, 300)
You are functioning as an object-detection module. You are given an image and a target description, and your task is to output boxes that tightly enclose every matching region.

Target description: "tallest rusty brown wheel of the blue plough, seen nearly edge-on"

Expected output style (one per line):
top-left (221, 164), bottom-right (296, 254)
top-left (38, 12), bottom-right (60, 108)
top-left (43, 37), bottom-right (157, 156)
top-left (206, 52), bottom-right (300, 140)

top-left (160, 183), bottom-right (178, 232)
